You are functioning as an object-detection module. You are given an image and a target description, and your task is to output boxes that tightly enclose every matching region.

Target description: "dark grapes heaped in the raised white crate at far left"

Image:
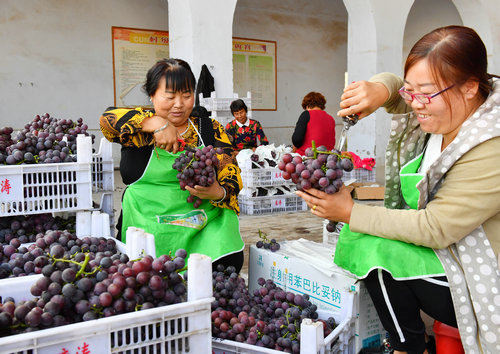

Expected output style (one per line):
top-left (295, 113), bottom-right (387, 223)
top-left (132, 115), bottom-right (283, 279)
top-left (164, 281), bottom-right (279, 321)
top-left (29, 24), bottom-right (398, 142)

top-left (0, 113), bottom-right (95, 165)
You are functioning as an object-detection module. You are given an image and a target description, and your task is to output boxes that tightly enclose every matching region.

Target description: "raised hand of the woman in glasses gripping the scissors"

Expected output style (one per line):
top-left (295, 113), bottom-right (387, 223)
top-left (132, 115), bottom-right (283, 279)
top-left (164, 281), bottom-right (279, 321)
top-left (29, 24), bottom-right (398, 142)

top-left (337, 81), bottom-right (389, 119)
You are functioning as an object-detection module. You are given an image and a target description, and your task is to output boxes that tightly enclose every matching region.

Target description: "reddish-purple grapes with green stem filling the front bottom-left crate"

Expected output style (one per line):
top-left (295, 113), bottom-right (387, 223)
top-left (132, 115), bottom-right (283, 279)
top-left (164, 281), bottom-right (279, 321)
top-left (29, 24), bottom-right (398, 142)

top-left (0, 246), bottom-right (186, 336)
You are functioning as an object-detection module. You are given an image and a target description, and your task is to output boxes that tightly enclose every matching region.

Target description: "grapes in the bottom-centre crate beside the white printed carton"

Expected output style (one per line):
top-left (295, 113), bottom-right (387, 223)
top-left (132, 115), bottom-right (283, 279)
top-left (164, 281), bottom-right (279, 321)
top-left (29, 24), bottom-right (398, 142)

top-left (212, 265), bottom-right (336, 353)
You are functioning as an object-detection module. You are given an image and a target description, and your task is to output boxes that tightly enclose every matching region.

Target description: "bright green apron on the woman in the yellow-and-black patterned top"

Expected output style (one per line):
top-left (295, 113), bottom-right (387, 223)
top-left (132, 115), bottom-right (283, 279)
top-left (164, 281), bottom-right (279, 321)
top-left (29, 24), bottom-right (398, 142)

top-left (122, 145), bottom-right (244, 261)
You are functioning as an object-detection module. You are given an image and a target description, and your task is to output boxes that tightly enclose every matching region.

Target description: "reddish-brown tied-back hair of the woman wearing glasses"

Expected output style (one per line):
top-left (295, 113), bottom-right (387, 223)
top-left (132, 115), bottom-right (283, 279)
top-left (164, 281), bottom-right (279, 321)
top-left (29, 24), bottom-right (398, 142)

top-left (404, 26), bottom-right (496, 104)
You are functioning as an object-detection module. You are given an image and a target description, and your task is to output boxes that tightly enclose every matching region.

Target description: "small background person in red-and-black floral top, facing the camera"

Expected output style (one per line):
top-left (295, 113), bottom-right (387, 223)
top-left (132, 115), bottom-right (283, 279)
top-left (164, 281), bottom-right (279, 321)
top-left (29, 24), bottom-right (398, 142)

top-left (226, 99), bottom-right (269, 151)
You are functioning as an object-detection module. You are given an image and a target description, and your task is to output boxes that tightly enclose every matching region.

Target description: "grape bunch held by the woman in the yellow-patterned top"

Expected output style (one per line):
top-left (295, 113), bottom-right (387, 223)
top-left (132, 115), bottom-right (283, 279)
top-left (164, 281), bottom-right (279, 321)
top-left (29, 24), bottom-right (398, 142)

top-left (172, 145), bottom-right (223, 208)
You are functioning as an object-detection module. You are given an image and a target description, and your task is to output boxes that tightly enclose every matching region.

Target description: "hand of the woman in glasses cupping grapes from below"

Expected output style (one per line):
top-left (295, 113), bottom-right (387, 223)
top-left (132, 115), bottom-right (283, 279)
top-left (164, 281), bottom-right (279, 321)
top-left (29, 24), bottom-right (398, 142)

top-left (295, 186), bottom-right (354, 224)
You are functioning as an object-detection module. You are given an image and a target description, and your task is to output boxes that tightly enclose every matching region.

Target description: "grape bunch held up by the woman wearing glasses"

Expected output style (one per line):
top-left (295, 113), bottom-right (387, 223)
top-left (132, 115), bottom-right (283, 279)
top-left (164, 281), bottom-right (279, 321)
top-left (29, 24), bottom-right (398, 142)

top-left (278, 141), bottom-right (354, 232)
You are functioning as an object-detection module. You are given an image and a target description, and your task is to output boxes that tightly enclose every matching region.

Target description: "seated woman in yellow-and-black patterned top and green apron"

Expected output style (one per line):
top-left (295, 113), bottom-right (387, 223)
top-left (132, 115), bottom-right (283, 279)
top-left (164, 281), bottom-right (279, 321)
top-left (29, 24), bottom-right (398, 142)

top-left (100, 59), bottom-right (244, 272)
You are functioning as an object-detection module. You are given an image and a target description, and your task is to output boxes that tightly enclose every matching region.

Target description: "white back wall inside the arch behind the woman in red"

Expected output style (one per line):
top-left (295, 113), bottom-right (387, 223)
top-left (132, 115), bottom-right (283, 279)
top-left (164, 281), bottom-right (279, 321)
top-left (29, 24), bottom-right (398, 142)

top-left (233, 0), bottom-right (347, 144)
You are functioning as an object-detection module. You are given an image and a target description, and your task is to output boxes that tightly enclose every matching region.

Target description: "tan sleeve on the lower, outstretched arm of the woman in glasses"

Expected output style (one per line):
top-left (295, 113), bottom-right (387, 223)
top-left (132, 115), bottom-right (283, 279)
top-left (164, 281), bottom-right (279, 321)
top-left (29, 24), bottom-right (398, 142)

top-left (349, 137), bottom-right (500, 254)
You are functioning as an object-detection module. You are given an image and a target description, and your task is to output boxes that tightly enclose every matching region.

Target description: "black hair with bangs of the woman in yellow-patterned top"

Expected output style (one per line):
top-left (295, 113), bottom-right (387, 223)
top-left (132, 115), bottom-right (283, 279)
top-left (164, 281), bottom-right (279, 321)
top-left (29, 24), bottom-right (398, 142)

top-left (142, 58), bottom-right (196, 96)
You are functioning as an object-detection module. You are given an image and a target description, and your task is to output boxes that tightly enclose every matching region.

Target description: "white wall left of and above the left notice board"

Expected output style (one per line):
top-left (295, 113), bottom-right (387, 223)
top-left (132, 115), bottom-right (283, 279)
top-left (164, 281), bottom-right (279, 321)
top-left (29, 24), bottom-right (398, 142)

top-left (0, 0), bottom-right (168, 155)
